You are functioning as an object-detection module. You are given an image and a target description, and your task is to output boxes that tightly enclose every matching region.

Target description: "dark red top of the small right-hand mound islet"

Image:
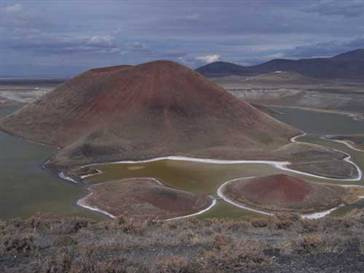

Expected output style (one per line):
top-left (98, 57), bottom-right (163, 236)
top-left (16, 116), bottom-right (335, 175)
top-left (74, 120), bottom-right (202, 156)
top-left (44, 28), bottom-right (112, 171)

top-left (243, 174), bottom-right (313, 203)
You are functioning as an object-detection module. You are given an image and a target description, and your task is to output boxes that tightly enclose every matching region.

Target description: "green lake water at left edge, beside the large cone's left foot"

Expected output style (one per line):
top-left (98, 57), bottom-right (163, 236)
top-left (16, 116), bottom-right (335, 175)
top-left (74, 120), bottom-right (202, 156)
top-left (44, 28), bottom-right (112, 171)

top-left (0, 104), bottom-right (100, 219)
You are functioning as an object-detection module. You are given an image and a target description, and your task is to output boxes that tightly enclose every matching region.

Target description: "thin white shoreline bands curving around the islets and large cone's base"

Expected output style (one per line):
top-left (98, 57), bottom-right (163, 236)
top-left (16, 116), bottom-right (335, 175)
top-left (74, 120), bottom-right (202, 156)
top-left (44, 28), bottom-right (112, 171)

top-left (59, 133), bottom-right (363, 221)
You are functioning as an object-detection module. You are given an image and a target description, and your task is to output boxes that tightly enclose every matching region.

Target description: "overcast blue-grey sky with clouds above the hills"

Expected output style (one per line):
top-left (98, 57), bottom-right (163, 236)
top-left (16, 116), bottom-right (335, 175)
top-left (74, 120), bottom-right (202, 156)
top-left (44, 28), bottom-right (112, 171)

top-left (0, 0), bottom-right (364, 77)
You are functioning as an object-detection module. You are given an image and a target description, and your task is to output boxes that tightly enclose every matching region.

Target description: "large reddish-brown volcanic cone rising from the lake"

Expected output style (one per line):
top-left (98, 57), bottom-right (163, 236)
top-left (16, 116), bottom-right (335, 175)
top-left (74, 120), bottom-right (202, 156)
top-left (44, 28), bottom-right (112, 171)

top-left (0, 61), bottom-right (297, 164)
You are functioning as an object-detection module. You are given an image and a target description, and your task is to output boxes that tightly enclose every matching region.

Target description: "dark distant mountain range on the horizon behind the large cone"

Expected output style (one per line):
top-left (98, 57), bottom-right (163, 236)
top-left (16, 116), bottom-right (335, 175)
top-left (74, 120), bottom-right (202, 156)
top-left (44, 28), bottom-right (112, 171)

top-left (196, 49), bottom-right (364, 79)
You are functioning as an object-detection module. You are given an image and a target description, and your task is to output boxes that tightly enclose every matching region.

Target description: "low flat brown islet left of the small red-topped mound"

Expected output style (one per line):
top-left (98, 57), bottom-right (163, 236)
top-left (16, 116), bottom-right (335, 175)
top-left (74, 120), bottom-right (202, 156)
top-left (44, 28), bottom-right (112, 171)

top-left (79, 178), bottom-right (212, 219)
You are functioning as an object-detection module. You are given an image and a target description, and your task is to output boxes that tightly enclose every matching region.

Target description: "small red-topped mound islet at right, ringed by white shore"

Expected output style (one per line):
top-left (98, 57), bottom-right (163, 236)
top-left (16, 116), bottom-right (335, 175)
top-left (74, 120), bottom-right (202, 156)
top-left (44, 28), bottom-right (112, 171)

top-left (224, 174), bottom-right (351, 212)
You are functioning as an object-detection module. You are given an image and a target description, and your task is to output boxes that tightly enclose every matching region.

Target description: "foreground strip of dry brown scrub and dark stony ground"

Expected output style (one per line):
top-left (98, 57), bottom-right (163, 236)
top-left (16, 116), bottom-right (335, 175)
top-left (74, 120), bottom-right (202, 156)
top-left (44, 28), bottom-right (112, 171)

top-left (0, 211), bottom-right (364, 273)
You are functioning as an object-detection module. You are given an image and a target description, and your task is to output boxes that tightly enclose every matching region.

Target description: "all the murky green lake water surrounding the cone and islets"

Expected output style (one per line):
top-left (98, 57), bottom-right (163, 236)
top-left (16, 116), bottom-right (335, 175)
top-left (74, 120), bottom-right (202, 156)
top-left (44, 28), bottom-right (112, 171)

top-left (0, 104), bottom-right (364, 219)
